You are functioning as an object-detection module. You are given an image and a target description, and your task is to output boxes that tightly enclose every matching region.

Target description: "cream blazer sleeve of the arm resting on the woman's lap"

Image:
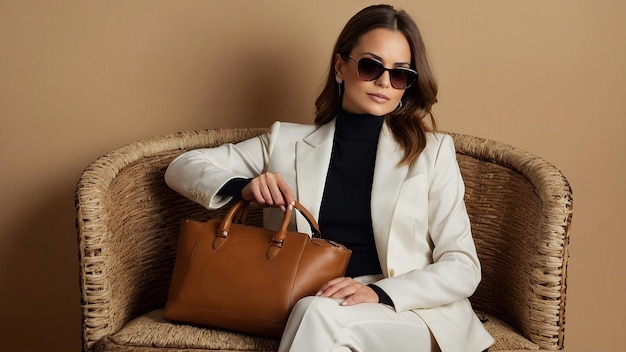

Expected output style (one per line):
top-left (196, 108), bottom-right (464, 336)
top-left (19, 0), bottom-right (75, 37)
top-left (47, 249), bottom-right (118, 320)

top-left (376, 136), bottom-right (481, 311)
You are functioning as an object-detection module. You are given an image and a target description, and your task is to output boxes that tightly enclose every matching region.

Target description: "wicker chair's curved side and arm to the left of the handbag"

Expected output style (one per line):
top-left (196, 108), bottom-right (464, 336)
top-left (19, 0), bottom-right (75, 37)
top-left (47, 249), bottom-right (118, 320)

top-left (76, 129), bottom-right (265, 350)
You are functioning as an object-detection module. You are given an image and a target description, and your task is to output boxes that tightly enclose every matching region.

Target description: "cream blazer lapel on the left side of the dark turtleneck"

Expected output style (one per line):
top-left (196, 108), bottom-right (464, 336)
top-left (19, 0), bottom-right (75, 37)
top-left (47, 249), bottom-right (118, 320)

top-left (296, 120), bottom-right (335, 233)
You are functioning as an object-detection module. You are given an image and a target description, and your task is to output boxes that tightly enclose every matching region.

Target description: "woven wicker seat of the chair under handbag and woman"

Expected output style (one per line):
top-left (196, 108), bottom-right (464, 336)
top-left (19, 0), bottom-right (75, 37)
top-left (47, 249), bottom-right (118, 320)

top-left (96, 309), bottom-right (539, 352)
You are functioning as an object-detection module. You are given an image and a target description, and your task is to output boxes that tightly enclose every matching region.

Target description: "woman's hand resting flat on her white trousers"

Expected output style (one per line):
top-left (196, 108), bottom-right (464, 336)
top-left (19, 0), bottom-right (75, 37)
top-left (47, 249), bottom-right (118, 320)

top-left (317, 277), bottom-right (378, 306)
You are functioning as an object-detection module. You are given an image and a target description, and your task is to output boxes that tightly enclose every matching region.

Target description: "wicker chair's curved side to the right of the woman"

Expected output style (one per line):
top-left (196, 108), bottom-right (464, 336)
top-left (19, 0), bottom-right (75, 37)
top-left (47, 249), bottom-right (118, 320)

top-left (451, 133), bottom-right (573, 350)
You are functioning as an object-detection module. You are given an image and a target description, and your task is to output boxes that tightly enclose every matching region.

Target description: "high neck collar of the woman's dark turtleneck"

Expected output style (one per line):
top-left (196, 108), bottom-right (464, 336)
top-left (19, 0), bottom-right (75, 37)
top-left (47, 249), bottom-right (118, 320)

top-left (336, 109), bottom-right (385, 140)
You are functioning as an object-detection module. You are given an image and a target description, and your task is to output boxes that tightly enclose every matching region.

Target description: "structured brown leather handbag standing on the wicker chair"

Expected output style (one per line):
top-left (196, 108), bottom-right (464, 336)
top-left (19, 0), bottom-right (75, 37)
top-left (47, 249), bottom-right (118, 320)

top-left (165, 201), bottom-right (351, 337)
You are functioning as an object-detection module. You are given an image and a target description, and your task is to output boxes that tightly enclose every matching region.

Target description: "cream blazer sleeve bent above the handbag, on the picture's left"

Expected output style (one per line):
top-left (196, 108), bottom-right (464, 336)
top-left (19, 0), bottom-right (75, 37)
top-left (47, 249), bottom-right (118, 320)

top-left (165, 122), bottom-right (280, 209)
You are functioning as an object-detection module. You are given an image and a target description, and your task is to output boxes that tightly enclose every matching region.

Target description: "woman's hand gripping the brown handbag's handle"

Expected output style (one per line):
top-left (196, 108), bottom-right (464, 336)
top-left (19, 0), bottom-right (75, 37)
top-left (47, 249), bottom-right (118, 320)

top-left (241, 172), bottom-right (296, 207)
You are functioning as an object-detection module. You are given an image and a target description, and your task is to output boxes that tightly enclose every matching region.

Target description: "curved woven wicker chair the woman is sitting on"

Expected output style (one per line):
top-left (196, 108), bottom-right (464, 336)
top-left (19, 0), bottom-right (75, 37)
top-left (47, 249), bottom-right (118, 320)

top-left (76, 129), bottom-right (572, 352)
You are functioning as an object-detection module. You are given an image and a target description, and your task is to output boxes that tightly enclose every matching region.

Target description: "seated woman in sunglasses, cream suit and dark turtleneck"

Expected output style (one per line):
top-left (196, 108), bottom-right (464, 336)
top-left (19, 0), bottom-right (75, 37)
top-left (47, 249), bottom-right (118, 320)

top-left (165, 5), bottom-right (494, 352)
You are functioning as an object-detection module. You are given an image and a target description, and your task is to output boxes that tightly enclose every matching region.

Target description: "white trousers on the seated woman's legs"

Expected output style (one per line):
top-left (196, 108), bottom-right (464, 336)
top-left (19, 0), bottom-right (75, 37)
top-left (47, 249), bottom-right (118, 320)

top-left (278, 297), bottom-right (439, 352)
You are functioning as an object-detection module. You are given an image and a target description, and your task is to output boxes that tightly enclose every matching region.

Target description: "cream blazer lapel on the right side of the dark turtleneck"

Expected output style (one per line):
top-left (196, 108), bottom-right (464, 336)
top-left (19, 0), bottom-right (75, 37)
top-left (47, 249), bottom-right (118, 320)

top-left (370, 124), bottom-right (408, 276)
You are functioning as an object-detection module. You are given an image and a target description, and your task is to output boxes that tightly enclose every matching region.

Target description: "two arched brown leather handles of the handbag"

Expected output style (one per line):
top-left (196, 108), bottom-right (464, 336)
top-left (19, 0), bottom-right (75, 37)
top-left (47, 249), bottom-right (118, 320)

top-left (213, 200), bottom-right (322, 259)
